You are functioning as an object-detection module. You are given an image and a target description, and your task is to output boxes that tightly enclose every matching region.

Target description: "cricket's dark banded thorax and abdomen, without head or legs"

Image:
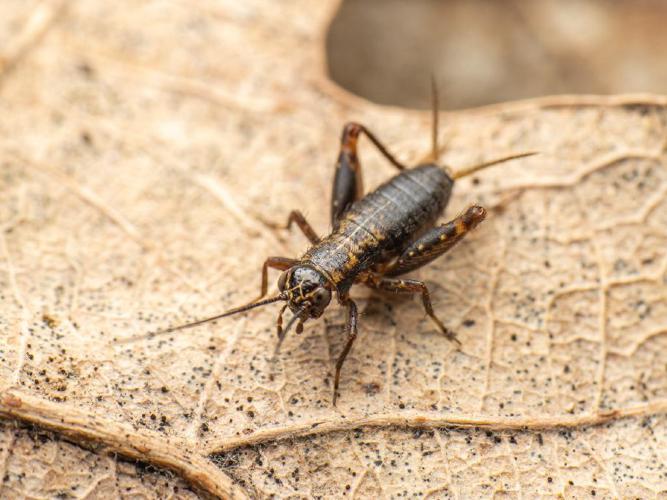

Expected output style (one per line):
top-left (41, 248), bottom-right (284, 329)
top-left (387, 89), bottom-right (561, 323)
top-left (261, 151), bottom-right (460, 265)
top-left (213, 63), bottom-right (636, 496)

top-left (302, 165), bottom-right (453, 291)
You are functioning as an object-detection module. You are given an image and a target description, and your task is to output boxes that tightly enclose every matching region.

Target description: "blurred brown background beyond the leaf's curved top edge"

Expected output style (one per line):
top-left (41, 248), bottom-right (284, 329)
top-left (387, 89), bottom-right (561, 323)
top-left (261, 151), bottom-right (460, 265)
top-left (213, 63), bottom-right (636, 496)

top-left (327, 0), bottom-right (667, 110)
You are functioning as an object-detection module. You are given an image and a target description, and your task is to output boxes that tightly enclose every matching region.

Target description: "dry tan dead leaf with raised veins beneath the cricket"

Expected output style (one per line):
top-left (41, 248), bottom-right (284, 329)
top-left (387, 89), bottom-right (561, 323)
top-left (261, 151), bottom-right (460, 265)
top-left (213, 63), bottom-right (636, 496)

top-left (0, 0), bottom-right (667, 498)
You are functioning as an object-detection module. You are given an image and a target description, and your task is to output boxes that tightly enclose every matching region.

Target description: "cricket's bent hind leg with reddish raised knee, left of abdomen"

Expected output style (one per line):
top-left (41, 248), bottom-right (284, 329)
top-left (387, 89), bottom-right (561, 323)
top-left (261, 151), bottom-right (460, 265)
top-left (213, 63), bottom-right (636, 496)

top-left (331, 122), bottom-right (406, 228)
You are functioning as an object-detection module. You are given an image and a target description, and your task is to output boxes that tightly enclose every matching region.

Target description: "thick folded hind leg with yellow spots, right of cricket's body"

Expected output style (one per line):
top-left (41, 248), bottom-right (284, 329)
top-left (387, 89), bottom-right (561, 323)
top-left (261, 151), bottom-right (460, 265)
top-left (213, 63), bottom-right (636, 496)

top-left (384, 205), bottom-right (486, 276)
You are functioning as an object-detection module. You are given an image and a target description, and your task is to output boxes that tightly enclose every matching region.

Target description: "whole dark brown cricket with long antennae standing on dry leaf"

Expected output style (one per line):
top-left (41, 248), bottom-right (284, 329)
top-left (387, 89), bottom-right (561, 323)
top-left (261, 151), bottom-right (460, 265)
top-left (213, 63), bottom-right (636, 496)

top-left (158, 85), bottom-right (535, 406)
